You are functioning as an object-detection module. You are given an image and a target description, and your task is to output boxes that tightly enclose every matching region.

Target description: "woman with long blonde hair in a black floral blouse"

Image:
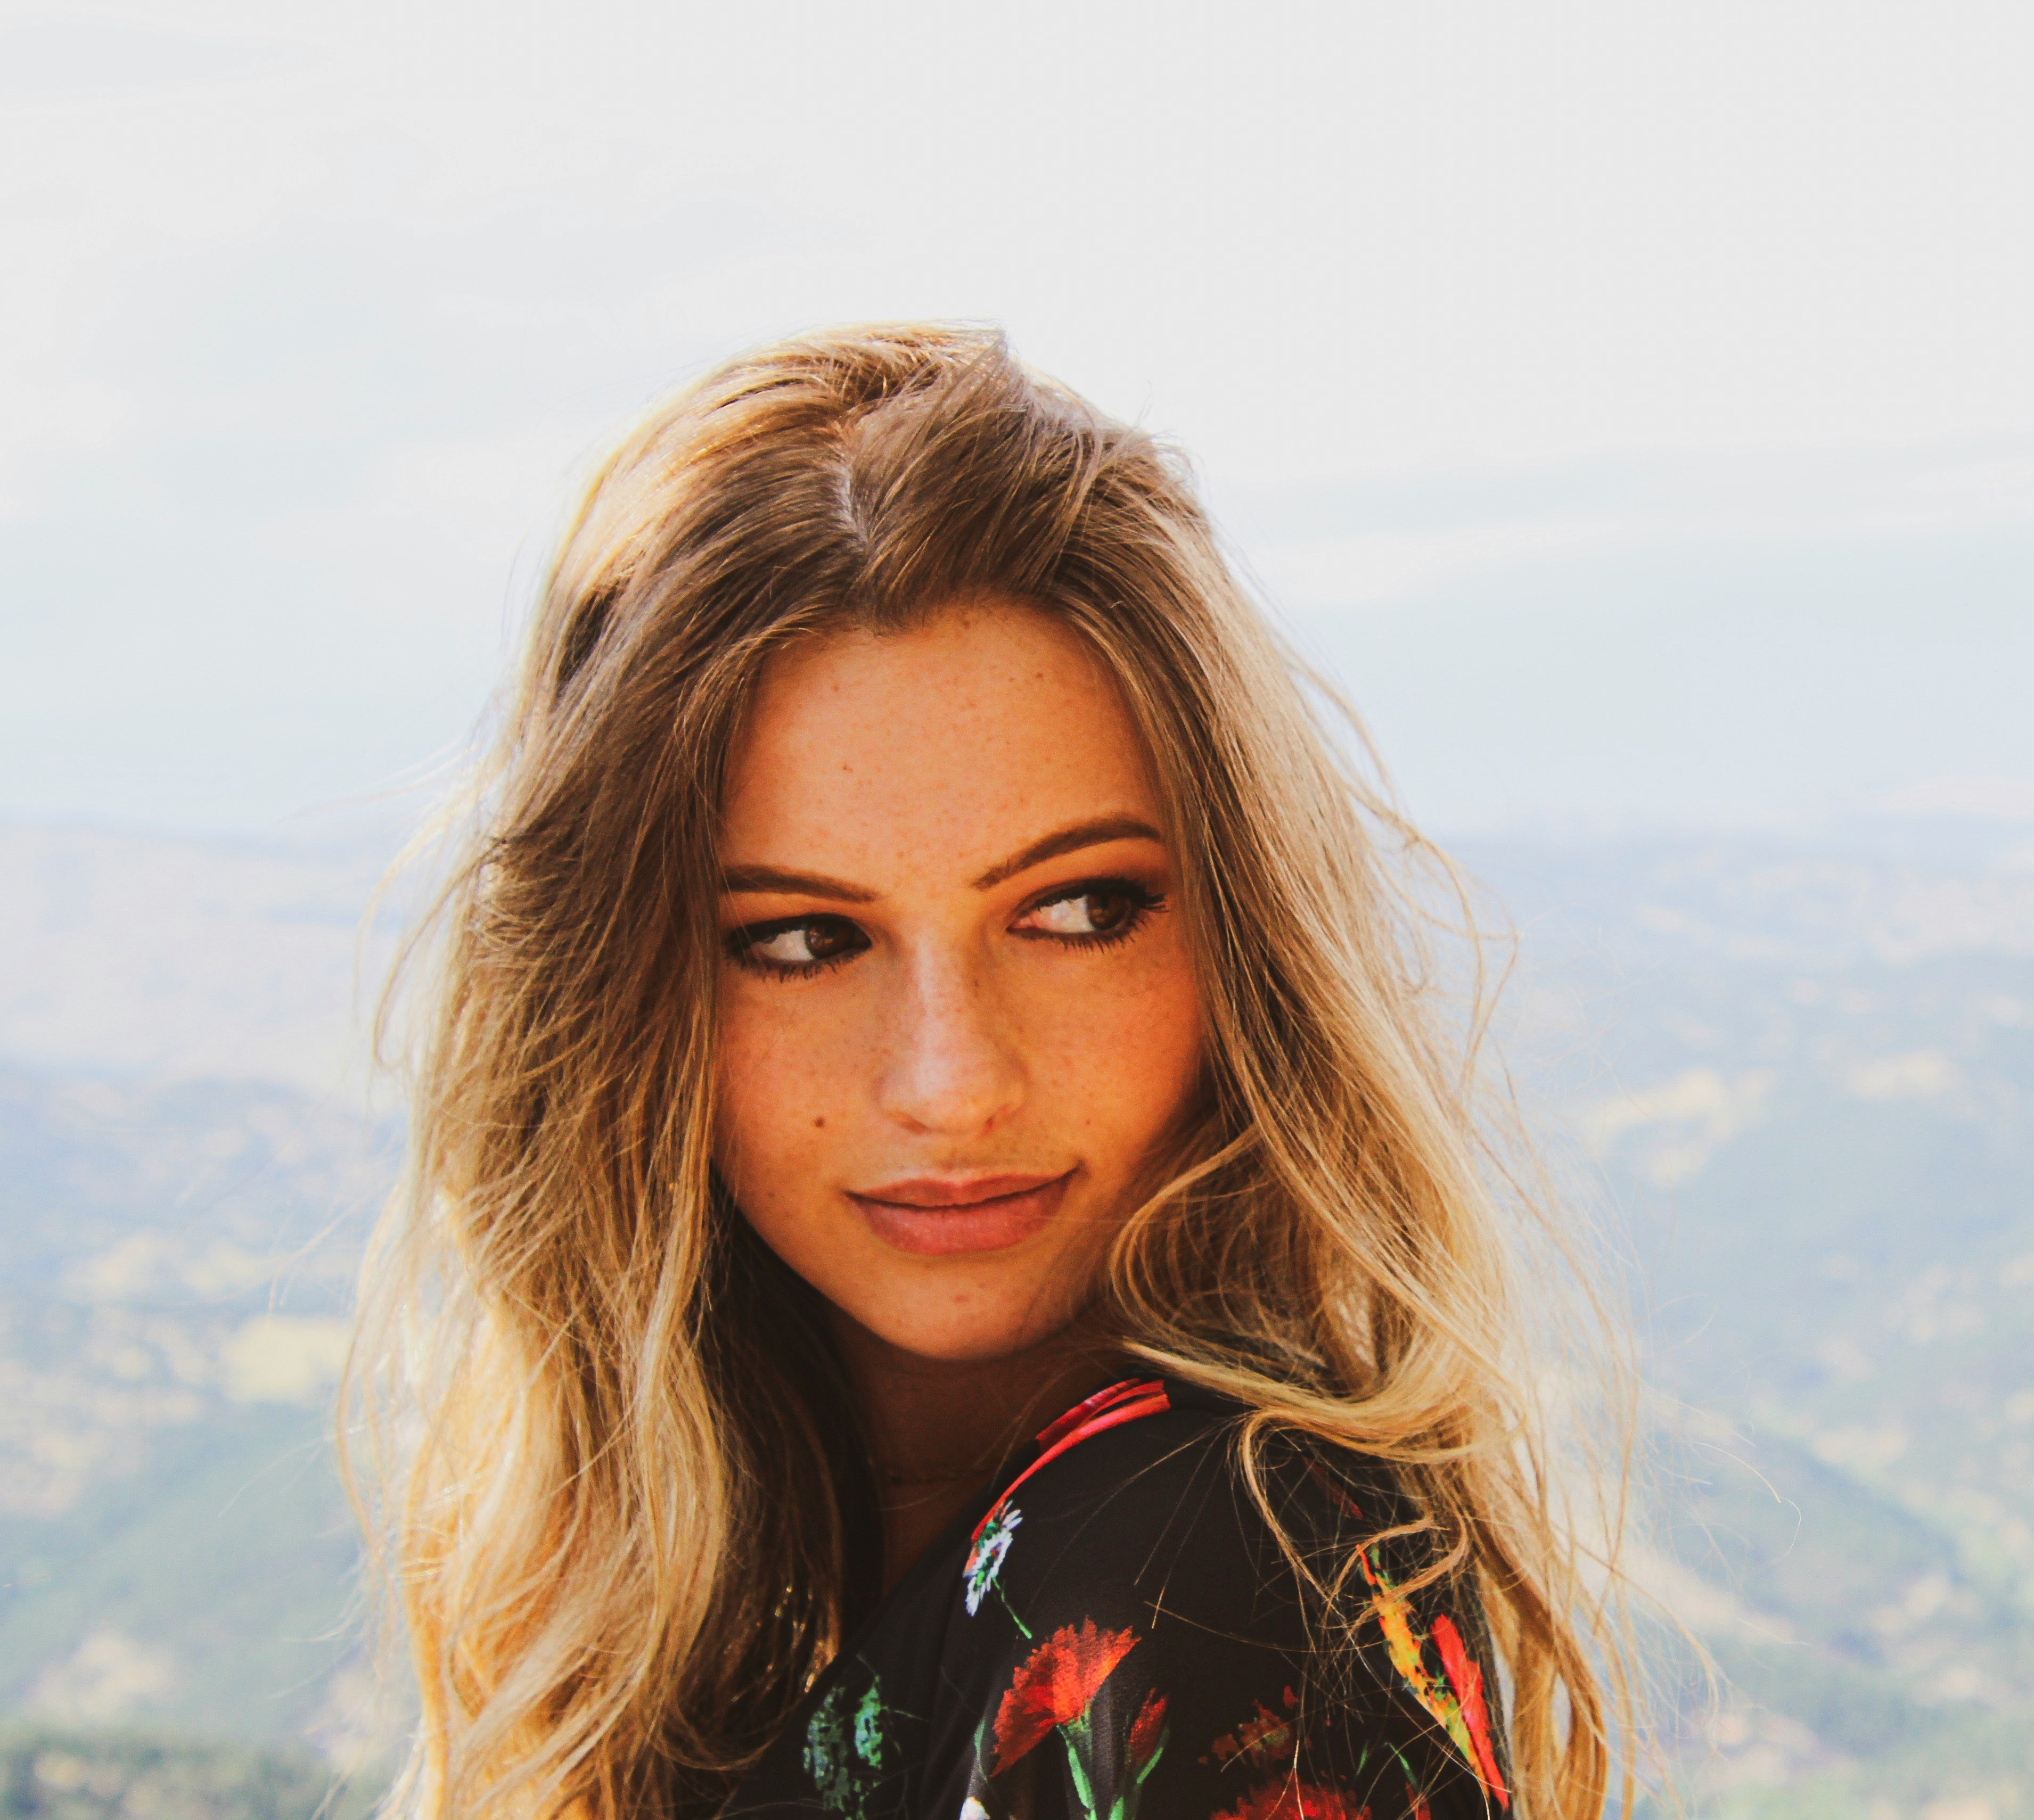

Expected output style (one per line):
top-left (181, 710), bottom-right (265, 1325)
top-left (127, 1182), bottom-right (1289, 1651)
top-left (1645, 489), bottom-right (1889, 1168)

top-left (354, 327), bottom-right (1635, 1820)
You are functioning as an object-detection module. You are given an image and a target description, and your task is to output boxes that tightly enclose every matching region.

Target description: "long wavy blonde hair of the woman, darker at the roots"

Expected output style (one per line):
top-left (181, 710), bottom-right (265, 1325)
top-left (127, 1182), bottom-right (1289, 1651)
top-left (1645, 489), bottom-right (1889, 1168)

top-left (352, 325), bottom-right (1627, 1820)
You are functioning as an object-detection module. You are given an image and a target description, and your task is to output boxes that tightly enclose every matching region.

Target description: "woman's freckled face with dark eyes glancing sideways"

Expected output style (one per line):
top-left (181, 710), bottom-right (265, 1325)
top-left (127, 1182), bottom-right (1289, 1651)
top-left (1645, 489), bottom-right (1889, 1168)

top-left (718, 604), bottom-right (1200, 1361)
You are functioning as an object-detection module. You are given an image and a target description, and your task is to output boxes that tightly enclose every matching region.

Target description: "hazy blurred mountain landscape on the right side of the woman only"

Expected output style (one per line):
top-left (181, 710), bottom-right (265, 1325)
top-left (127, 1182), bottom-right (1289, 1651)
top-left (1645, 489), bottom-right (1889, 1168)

top-left (1469, 823), bottom-right (2034, 1820)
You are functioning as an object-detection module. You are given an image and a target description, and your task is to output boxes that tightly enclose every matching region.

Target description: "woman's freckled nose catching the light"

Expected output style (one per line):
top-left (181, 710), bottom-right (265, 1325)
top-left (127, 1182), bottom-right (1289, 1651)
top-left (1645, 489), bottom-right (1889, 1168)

top-left (876, 954), bottom-right (1023, 1137)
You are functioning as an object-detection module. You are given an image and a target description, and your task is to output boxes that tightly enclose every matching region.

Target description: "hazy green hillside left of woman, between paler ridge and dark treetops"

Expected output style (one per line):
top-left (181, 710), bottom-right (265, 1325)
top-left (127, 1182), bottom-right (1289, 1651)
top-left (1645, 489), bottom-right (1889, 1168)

top-left (0, 1072), bottom-right (387, 1751)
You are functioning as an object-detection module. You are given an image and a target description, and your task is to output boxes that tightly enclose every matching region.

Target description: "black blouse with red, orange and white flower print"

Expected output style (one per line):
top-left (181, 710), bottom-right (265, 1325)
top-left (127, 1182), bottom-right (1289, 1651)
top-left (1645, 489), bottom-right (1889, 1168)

top-left (724, 1379), bottom-right (1511, 1820)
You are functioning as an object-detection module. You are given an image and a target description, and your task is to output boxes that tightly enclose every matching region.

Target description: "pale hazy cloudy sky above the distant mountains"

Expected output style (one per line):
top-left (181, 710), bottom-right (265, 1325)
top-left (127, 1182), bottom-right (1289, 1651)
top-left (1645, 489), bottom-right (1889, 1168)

top-left (0, 0), bottom-right (2034, 834)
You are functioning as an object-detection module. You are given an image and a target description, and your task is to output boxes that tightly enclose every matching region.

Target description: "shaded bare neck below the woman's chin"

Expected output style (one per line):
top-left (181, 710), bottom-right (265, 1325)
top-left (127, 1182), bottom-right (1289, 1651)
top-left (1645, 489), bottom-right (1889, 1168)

top-left (834, 1312), bottom-right (1129, 1592)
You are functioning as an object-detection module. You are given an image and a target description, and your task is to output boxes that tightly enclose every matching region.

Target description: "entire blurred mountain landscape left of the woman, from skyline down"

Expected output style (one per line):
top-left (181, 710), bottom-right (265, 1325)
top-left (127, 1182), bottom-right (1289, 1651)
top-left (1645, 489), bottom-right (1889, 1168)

top-left (0, 826), bottom-right (397, 1820)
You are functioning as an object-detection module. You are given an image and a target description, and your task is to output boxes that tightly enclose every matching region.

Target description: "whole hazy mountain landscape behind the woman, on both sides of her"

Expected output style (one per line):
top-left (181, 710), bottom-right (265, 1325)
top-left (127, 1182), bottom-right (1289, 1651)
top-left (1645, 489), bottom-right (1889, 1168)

top-left (0, 816), bottom-right (2034, 1820)
